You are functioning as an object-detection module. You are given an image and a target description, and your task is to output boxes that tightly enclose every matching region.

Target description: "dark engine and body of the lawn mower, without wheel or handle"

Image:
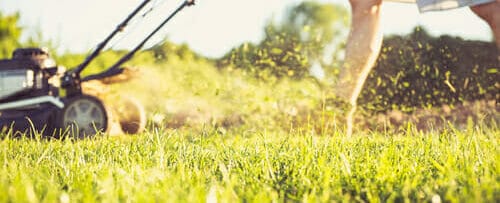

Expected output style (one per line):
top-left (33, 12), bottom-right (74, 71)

top-left (0, 48), bottom-right (64, 135)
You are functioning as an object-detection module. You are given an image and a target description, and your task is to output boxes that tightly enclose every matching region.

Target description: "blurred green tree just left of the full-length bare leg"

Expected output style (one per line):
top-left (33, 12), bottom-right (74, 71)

top-left (218, 1), bottom-right (347, 79)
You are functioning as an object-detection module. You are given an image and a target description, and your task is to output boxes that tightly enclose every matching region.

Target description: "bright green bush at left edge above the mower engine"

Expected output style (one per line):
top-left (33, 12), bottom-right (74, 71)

top-left (0, 12), bottom-right (22, 59)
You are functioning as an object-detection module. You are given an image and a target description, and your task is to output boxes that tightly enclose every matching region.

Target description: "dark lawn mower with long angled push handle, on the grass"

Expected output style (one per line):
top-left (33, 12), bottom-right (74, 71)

top-left (0, 0), bottom-right (194, 138)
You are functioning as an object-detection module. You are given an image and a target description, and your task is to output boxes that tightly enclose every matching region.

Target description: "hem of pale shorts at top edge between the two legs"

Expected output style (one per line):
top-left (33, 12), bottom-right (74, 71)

top-left (386, 0), bottom-right (495, 12)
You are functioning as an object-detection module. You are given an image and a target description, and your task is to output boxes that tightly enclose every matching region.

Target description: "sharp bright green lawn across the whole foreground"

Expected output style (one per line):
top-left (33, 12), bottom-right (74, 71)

top-left (0, 125), bottom-right (500, 202)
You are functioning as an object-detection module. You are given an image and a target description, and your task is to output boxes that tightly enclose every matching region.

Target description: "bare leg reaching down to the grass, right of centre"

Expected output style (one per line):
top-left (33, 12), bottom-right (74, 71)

top-left (336, 0), bottom-right (382, 136)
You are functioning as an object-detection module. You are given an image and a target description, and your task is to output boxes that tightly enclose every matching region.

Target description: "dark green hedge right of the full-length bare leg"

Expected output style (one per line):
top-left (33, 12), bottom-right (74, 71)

top-left (360, 27), bottom-right (500, 111)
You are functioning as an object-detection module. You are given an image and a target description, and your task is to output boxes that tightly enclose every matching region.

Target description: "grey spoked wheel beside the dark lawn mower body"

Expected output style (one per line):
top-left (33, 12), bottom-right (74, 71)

top-left (57, 95), bottom-right (108, 138)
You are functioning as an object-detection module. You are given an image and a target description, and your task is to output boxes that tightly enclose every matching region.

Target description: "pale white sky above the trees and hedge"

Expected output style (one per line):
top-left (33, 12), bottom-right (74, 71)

top-left (0, 0), bottom-right (492, 57)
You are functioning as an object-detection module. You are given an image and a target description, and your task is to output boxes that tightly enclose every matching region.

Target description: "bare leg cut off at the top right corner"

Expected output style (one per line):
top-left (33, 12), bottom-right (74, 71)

top-left (471, 0), bottom-right (500, 49)
